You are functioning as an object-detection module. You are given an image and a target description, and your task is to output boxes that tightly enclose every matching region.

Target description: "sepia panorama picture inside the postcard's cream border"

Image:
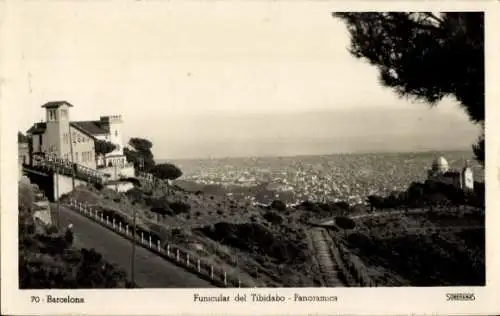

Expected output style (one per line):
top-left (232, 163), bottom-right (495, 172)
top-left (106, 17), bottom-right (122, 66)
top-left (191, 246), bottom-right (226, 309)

top-left (2, 1), bottom-right (496, 314)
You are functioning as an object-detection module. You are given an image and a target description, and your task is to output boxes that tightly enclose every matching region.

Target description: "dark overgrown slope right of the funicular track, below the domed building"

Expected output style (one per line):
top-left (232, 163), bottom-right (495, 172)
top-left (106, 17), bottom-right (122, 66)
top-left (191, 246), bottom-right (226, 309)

top-left (341, 210), bottom-right (485, 286)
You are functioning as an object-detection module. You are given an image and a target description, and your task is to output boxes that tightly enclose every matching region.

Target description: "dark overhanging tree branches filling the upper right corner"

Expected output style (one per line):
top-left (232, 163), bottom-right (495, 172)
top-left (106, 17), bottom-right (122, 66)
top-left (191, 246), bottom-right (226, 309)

top-left (333, 12), bottom-right (485, 164)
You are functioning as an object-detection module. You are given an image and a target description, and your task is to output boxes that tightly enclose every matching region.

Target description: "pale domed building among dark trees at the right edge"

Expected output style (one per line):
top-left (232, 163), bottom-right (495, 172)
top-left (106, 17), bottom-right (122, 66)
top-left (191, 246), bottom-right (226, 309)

top-left (427, 156), bottom-right (474, 190)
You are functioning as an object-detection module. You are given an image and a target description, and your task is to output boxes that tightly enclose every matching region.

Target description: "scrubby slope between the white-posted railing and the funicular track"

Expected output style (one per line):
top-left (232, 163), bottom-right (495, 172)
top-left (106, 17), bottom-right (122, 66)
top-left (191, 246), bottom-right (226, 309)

top-left (65, 183), bottom-right (318, 286)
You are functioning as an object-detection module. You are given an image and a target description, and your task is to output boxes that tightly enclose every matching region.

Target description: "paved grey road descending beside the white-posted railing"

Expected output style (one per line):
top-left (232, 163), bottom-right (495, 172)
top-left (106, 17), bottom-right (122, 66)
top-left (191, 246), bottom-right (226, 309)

top-left (51, 205), bottom-right (215, 288)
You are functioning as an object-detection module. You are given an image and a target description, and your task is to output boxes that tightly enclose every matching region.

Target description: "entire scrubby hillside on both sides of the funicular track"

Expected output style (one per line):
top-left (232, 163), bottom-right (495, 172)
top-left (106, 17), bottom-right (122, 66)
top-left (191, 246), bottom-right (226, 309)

top-left (61, 177), bottom-right (484, 287)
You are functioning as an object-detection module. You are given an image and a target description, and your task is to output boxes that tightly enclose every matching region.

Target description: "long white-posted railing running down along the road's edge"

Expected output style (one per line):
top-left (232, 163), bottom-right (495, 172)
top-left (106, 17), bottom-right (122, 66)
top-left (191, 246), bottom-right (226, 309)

top-left (66, 199), bottom-right (250, 287)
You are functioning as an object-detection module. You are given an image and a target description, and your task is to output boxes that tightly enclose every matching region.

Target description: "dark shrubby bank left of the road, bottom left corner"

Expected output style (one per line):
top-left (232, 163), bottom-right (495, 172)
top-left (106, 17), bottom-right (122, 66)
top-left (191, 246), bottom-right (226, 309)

top-left (19, 183), bottom-right (131, 289)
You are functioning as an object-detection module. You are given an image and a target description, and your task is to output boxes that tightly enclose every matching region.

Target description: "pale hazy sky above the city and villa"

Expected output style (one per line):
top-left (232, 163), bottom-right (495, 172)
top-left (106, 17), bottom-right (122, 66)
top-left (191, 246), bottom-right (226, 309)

top-left (4, 1), bottom-right (478, 159)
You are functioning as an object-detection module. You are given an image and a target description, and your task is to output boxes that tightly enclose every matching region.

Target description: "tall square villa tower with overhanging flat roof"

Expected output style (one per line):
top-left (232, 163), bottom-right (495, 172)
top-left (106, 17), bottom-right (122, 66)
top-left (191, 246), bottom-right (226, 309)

top-left (40, 101), bottom-right (73, 158)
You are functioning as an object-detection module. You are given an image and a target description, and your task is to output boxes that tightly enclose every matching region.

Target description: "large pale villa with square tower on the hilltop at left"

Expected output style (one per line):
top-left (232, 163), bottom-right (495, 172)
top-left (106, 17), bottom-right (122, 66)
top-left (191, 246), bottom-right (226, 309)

top-left (27, 101), bottom-right (127, 169)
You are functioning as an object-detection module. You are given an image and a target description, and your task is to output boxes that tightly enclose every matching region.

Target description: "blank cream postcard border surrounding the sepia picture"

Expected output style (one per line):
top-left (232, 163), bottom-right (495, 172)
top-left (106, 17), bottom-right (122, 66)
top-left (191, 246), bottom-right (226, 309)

top-left (0, 1), bottom-right (500, 315)
